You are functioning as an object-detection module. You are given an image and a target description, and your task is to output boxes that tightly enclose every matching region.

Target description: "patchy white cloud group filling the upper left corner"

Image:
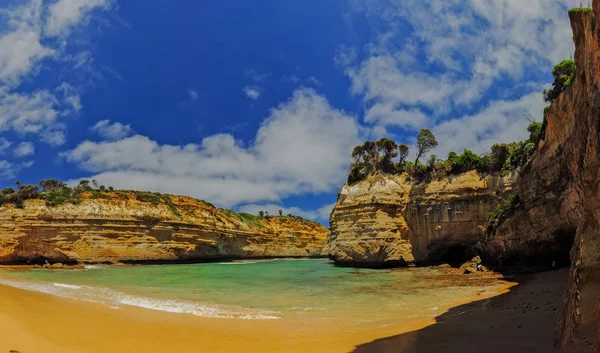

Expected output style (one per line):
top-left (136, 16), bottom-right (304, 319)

top-left (0, 0), bottom-right (108, 146)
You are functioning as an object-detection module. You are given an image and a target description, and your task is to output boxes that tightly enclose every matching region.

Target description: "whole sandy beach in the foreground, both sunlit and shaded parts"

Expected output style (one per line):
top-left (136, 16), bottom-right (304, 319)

top-left (0, 270), bottom-right (584, 353)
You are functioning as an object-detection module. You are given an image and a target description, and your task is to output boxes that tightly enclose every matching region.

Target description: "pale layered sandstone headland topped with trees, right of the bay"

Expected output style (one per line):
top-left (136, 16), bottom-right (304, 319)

top-left (329, 171), bottom-right (513, 267)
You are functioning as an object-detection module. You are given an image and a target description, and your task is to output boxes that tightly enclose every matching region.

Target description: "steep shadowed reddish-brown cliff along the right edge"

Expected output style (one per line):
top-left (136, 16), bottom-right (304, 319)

top-left (496, 10), bottom-right (600, 352)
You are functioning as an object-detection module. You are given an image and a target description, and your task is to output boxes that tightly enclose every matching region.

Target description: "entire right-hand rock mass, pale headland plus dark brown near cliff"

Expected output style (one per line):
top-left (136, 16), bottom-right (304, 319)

top-left (329, 8), bottom-right (600, 352)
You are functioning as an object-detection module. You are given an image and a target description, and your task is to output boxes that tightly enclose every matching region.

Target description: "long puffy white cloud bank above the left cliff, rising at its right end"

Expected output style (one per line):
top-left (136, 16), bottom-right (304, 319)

top-left (63, 89), bottom-right (360, 207)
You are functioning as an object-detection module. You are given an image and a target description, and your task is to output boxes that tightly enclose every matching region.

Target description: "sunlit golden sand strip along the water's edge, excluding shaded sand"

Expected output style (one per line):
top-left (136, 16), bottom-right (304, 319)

top-left (0, 266), bottom-right (513, 353)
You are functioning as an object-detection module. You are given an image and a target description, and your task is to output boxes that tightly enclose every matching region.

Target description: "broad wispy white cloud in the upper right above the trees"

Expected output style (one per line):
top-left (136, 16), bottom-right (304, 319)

top-left (342, 0), bottom-right (573, 152)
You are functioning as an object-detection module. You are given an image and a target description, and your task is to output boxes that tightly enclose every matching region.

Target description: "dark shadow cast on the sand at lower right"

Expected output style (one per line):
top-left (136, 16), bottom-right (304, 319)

top-left (353, 269), bottom-right (593, 353)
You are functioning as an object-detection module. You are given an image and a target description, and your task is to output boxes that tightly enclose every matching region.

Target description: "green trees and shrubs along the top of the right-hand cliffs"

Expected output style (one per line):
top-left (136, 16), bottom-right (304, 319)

top-left (348, 57), bottom-right (576, 184)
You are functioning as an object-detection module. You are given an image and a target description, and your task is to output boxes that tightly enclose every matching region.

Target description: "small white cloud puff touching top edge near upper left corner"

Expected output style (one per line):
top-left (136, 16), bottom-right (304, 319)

top-left (44, 0), bottom-right (110, 37)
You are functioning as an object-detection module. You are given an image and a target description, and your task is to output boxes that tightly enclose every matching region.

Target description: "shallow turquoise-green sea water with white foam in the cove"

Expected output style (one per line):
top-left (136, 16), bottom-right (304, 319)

top-left (0, 259), bottom-right (506, 326)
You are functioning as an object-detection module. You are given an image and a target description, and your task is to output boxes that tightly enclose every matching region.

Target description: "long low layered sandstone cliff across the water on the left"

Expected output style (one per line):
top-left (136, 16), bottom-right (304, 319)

top-left (0, 193), bottom-right (327, 264)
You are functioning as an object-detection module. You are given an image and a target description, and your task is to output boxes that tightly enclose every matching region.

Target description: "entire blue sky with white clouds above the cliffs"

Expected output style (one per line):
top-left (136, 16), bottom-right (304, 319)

top-left (0, 0), bottom-right (575, 222)
